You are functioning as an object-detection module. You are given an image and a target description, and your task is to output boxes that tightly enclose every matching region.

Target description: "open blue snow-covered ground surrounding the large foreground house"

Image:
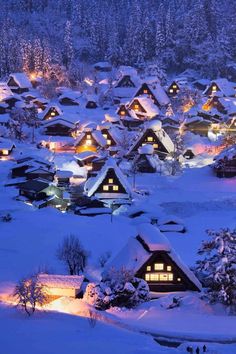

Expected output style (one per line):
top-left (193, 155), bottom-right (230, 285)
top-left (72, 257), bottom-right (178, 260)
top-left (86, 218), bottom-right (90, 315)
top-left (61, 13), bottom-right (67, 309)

top-left (0, 148), bottom-right (236, 354)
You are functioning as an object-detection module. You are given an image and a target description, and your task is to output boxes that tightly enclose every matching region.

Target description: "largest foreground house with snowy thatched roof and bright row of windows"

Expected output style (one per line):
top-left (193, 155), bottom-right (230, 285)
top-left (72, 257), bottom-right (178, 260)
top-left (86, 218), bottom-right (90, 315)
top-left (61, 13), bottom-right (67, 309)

top-left (105, 224), bottom-right (201, 292)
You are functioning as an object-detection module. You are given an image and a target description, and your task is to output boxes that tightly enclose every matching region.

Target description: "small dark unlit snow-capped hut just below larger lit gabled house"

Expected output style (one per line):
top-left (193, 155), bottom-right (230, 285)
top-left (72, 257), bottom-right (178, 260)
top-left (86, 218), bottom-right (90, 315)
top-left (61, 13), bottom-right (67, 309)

top-left (133, 144), bottom-right (160, 173)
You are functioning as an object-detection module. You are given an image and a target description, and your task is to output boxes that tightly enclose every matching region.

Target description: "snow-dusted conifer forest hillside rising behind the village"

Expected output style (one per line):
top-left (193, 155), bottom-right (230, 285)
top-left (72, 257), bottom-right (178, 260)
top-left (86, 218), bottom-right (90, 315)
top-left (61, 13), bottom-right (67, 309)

top-left (0, 0), bottom-right (236, 77)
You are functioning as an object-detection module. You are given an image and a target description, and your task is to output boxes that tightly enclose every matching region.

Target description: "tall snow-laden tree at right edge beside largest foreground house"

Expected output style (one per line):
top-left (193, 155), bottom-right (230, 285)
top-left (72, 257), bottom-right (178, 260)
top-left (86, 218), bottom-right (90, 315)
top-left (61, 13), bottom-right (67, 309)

top-left (196, 229), bottom-right (236, 314)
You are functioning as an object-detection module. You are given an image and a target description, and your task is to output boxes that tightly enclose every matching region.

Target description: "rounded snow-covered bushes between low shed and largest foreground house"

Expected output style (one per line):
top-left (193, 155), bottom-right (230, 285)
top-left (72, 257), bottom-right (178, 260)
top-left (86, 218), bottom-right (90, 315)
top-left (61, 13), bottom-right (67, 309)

top-left (84, 268), bottom-right (149, 310)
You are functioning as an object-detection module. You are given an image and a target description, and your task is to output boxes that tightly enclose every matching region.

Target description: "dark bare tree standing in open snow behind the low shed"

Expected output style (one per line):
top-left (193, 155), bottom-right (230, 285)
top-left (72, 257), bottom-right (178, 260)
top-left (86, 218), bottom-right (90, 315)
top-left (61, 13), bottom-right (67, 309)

top-left (56, 235), bottom-right (88, 275)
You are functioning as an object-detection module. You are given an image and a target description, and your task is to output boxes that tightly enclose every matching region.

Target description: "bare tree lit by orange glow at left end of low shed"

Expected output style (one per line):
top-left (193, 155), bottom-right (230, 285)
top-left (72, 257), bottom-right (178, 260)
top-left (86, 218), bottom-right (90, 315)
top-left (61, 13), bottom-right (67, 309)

top-left (14, 275), bottom-right (47, 316)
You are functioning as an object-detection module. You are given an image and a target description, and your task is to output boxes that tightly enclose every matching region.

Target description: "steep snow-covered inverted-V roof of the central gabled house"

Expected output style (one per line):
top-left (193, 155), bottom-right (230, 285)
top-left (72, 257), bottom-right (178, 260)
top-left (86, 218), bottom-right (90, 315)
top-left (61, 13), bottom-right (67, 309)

top-left (84, 158), bottom-right (132, 197)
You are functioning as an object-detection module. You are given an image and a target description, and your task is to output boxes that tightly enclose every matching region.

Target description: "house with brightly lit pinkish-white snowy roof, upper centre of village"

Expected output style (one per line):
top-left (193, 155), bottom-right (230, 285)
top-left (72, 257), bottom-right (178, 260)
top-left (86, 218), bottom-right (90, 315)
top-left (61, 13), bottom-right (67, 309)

top-left (128, 95), bottom-right (160, 120)
